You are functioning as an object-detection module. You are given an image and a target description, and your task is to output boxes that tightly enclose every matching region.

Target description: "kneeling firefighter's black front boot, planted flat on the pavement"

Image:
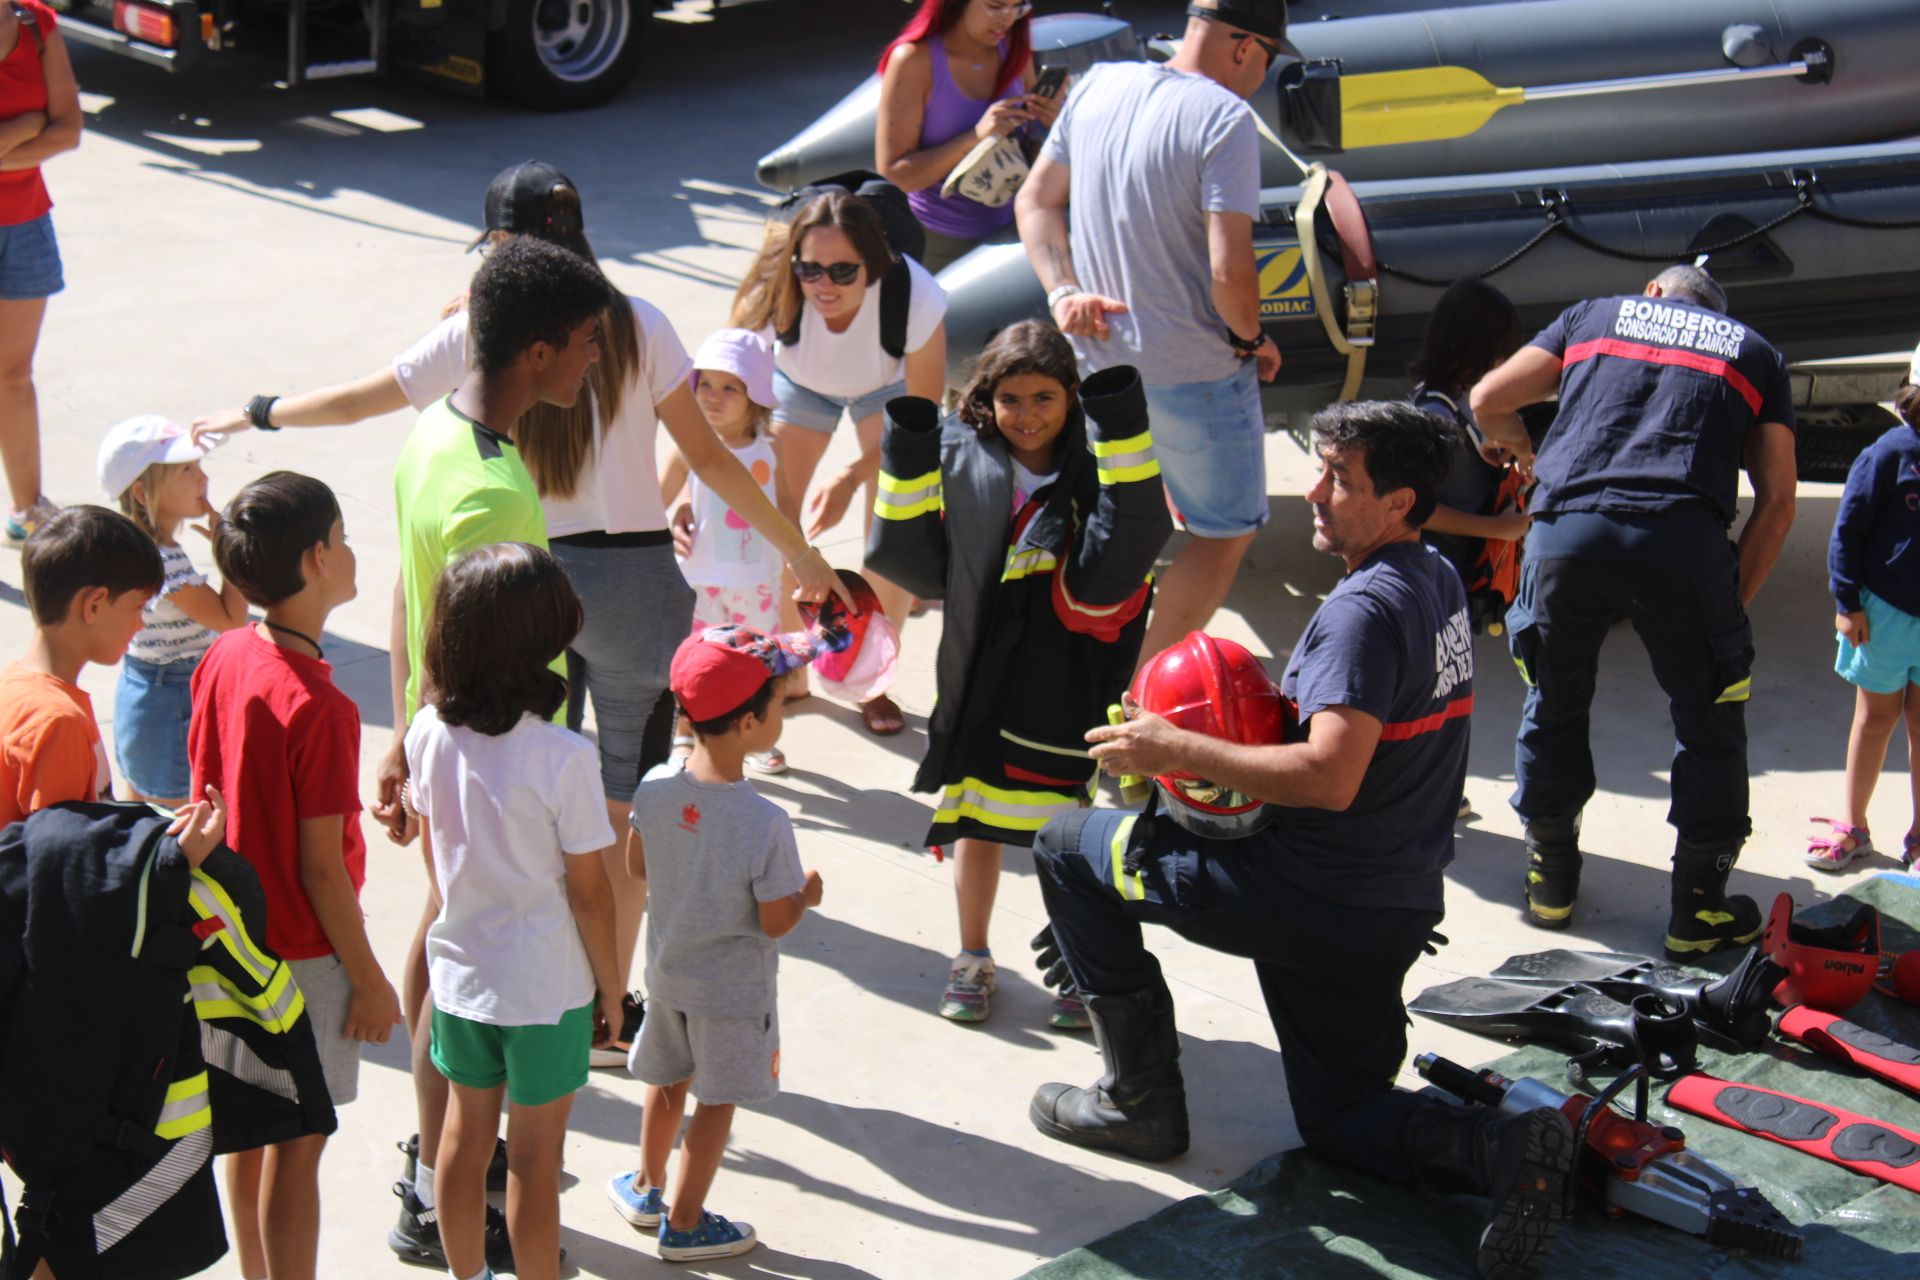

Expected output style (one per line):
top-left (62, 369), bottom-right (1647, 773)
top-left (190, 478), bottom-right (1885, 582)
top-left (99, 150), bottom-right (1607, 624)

top-left (1027, 984), bottom-right (1187, 1161)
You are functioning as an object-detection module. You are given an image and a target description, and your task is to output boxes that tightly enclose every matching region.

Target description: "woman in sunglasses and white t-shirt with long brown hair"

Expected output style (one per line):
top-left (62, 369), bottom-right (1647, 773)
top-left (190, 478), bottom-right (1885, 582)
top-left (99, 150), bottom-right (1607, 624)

top-left (732, 192), bottom-right (947, 737)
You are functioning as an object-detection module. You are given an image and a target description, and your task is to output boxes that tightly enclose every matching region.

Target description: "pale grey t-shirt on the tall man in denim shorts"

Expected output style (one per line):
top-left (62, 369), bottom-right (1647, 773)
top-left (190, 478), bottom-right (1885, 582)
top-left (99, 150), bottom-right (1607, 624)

top-left (1044, 61), bottom-right (1260, 386)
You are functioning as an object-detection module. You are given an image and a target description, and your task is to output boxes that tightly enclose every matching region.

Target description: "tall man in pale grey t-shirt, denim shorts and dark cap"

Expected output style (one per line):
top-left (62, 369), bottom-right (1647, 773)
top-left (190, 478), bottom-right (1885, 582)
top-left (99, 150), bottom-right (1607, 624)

top-left (1016, 0), bottom-right (1292, 675)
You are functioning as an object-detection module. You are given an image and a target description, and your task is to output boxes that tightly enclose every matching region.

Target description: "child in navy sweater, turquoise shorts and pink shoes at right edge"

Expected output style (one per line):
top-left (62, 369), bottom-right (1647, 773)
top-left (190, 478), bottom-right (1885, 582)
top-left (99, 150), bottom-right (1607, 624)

top-left (1807, 351), bottom-right (1920, 871)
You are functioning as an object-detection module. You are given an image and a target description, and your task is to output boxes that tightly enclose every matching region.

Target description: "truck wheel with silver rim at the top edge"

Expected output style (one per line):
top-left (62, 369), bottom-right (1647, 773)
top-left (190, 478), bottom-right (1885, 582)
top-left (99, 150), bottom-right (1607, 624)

top-left (488, 0), bottom-right (649, 111)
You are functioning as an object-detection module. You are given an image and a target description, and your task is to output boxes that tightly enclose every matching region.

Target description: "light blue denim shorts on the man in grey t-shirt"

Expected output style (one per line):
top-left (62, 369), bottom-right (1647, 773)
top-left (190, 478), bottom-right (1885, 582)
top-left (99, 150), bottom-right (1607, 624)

top-left (1146, 361), bottom-right (1267, 537)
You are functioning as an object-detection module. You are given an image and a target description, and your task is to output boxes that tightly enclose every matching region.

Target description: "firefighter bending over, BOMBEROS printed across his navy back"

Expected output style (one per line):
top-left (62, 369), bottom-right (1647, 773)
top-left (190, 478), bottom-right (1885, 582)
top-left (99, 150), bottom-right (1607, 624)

top-left (1473, 267), bottom-right (1795, 961)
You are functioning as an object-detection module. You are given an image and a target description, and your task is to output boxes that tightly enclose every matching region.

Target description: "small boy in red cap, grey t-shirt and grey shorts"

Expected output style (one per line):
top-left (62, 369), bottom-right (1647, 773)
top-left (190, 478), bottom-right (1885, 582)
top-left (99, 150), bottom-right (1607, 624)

top-left (607, 626), bottom-right (822, 1263)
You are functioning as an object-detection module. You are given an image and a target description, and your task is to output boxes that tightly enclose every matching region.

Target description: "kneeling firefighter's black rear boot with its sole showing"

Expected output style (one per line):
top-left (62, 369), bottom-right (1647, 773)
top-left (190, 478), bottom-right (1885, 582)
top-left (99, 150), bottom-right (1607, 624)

top-left (1405, 1103), bottom-right (1574, 1280)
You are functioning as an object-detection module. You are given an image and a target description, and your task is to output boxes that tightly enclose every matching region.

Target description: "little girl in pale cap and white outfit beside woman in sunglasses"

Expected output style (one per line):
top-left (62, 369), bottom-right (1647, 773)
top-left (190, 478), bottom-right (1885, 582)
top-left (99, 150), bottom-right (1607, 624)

top-left (660, 328), bottom-right (787, 773)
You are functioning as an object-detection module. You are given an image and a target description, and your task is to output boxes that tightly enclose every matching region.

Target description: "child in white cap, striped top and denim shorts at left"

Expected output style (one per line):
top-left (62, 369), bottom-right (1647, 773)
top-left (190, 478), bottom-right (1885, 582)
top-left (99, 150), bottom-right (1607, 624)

top-left (100, 415), bottom-right (246, 808)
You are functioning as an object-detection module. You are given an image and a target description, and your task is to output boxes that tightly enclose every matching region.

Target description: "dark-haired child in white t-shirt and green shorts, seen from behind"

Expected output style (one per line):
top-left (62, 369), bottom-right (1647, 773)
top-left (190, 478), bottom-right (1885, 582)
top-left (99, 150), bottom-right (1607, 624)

top-left (405, 543), bottom-right (624, 1276)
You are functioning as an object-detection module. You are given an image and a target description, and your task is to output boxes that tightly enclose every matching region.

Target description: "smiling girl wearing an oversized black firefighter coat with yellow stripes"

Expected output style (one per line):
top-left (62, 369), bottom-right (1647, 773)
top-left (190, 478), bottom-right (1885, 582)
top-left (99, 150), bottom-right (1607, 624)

top-left (868, 320), bottom-right (1173, 1029)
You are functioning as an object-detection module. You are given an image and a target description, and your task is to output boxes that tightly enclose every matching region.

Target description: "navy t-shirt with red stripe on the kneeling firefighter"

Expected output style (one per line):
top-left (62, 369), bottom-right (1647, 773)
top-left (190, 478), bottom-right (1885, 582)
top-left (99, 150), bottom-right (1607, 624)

top-left (1273, 543), bottom-right (1473, 912)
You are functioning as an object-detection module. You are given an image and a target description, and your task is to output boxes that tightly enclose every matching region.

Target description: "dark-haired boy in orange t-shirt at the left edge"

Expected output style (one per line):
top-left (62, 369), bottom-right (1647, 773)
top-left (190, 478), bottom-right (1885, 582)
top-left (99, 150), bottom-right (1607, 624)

top-left (0, 507), bottom-right (165, 827)
